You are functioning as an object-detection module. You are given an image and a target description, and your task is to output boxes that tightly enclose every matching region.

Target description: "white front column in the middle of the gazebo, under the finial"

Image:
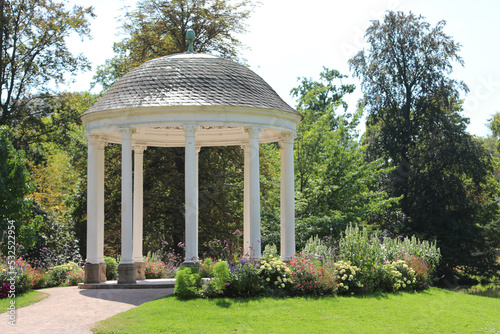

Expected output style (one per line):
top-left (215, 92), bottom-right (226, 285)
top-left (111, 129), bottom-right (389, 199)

top-left (183, 125), bottom-right (198, 264)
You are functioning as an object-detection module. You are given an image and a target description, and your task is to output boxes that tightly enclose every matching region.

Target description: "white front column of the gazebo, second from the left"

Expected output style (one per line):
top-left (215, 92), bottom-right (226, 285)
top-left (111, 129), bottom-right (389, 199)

top-left (119, 128), bottom-right (134, 264)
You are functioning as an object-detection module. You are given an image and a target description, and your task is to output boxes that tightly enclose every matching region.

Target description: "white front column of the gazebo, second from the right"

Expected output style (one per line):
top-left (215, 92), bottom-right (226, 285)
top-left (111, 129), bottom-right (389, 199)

top-left (246, 127), bottom-right (262, 258)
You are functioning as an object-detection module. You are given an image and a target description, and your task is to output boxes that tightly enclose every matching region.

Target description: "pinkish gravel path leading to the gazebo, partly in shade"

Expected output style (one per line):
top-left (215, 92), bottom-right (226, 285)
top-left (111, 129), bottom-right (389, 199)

top-left (0, 286), bottom-right (174, 334)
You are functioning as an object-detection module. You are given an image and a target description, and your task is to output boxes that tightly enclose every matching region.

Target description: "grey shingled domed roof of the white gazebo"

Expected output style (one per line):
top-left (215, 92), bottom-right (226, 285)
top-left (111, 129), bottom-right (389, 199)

top-left (84, 53), bottom-right (298, 115)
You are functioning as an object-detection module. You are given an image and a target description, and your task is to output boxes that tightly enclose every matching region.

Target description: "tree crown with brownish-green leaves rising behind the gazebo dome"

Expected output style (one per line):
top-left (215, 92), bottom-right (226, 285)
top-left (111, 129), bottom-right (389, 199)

top-left (95, 0), bottom-right (254, 89)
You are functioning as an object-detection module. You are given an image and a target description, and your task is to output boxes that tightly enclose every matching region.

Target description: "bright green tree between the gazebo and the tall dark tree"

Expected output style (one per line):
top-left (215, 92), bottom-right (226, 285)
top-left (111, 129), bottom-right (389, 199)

top-left (292, 68), bottom-right (396, 248)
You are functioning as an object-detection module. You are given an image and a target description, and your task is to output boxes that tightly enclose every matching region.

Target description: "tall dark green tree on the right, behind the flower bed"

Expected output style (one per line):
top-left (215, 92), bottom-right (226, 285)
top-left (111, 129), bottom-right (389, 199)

top-left (349, 12), bottom-right (498, 272)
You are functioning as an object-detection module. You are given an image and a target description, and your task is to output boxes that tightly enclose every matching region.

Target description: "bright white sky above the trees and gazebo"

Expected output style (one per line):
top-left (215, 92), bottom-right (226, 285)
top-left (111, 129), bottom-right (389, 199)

top-left (66, 0), bottom-right (500, 137)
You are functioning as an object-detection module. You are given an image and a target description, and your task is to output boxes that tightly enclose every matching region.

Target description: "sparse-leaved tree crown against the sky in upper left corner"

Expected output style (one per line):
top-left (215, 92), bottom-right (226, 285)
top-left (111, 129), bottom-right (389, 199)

top-left (0, 0), bottom-right (94, 125)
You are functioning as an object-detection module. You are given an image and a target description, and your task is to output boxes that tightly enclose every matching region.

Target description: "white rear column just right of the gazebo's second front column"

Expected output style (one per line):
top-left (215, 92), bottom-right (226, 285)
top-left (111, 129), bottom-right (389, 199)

top-left (132, 145), bottom-right (147, 262)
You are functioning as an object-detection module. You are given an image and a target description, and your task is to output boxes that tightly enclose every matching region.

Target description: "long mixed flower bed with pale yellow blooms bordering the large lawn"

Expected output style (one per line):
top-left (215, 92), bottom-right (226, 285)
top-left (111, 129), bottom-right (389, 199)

top-left (176, 226), bottom-right (440, 298)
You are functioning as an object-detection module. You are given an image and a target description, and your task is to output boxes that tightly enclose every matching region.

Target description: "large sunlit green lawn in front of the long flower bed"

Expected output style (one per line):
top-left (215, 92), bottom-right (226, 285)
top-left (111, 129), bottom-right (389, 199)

top-left (94, 288), bottom-right (500, 333)
